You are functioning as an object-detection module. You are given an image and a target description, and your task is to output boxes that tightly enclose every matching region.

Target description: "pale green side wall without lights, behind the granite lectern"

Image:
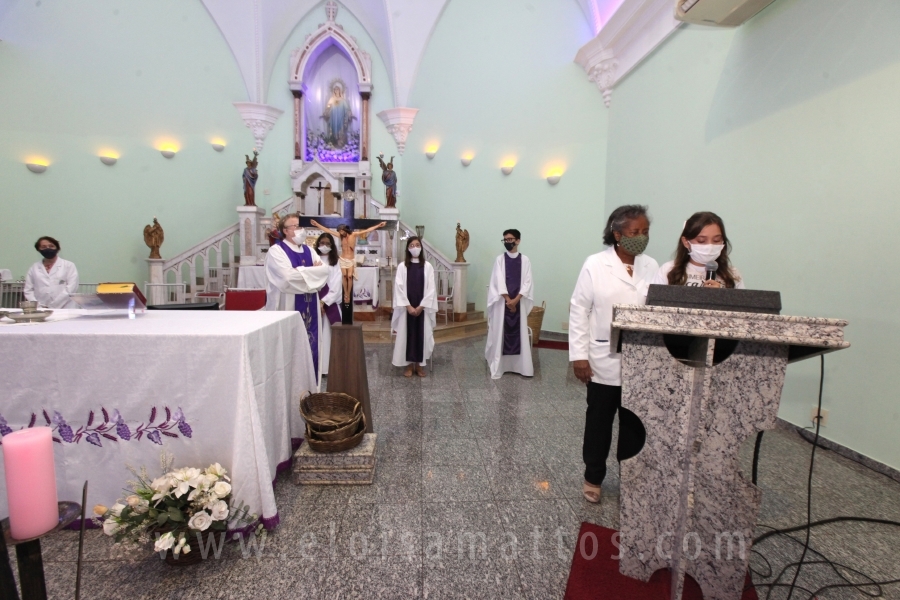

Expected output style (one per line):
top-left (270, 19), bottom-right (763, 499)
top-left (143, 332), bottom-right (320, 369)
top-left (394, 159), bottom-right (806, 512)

top-left (606, 0), bottom-right (900, 467)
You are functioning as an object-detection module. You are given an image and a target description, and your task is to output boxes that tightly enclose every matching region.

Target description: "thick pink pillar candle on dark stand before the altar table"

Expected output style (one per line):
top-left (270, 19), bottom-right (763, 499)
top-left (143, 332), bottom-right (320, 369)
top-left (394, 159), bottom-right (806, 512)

top-left (0, 427), bottom-right (59, 540)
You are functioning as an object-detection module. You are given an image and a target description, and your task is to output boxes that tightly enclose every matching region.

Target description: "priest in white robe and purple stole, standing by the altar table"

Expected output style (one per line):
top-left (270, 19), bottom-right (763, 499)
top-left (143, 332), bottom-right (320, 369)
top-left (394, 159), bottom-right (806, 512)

top-left (266, 214), bottom-right (330, 376)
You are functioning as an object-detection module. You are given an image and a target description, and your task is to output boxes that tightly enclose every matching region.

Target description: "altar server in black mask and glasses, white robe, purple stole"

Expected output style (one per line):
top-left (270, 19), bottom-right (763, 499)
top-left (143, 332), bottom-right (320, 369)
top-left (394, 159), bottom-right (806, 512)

top-left (484, 229), bottom-right (534, 379)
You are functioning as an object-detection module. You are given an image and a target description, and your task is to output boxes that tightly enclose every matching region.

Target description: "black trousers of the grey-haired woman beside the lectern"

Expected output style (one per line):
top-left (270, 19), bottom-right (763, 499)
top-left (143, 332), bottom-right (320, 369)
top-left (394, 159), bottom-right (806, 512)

top-left (581, 381), bottom-right (647, 485)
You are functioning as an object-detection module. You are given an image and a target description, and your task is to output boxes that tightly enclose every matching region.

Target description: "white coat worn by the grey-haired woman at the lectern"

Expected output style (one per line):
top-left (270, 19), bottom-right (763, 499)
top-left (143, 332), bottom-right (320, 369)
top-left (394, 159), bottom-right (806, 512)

top-left (569, 246), bottom-right (659, 385)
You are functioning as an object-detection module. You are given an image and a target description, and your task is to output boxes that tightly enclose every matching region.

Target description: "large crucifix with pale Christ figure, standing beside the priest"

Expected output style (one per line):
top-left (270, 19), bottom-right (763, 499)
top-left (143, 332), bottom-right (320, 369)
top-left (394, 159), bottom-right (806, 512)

top-left (300, 191), bottom-right (399, 325)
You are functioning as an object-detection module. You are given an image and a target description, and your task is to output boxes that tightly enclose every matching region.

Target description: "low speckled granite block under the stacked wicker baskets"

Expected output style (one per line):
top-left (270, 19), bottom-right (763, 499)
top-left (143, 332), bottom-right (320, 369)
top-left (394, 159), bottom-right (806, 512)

top-left (294, 433), bottom-right (377, 485)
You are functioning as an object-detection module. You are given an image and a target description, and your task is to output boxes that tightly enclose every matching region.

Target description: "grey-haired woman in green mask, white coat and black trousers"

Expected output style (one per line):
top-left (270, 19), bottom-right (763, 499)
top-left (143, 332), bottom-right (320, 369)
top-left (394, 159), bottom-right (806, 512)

top-left (569, 205), bottom-right (659, 503)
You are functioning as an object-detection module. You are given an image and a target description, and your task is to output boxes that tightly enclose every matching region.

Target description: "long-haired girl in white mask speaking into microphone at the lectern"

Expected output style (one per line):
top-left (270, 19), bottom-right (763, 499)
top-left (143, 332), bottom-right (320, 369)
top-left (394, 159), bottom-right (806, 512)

top-left (652, 211), bottom-right (744, 290)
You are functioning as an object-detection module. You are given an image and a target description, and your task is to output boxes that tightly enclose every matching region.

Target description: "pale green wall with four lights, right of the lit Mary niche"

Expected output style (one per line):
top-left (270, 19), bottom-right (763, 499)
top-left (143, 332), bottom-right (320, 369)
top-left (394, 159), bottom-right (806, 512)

top-left (398, 0), bottom-right (607, 331)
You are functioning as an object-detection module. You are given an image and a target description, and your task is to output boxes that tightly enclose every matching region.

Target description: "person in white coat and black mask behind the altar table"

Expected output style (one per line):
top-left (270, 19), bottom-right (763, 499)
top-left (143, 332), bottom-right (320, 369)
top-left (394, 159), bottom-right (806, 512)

top-left (24, 235), bottom-right (78, 308)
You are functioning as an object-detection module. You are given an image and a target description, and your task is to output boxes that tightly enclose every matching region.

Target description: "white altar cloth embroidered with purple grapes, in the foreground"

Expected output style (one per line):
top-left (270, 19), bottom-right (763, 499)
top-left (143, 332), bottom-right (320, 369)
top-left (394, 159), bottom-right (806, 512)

top-left (0, 311), bottom-right (316, 527)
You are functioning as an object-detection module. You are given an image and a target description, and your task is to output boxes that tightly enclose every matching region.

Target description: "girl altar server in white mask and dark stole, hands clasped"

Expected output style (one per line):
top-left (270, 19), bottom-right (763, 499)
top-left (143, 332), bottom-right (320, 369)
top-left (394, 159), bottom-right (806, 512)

top-left (391, 236), bottom-right (438, 377)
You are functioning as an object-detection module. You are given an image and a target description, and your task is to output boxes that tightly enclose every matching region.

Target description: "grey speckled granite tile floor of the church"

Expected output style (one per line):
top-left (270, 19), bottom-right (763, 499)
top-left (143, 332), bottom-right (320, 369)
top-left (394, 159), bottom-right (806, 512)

top-left (13, 338), bottom-right (900, 600)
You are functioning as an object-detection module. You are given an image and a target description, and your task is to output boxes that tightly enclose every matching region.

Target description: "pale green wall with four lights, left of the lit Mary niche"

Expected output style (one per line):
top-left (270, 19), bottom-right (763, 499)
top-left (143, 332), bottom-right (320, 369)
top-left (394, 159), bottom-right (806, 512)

top-left (0, 0), bottom-right (253, 284)
